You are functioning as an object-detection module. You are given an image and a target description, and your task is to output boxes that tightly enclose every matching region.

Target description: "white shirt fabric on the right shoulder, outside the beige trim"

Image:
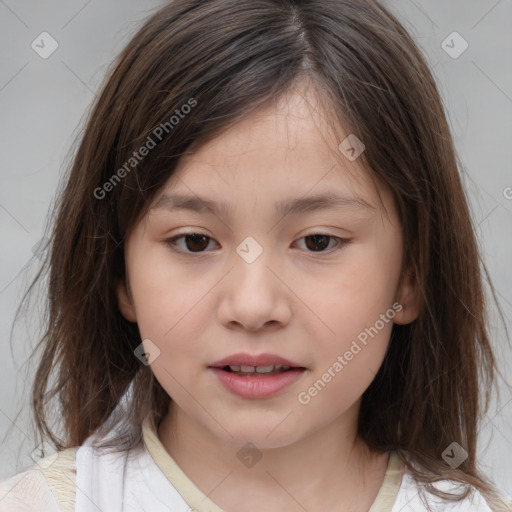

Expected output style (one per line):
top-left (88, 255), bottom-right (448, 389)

top-left (392, 471), bottom-right (512, 512)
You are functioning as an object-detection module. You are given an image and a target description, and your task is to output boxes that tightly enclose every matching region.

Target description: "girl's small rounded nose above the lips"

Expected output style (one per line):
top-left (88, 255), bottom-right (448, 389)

top-left (218, 247), bottom-right (293, 332)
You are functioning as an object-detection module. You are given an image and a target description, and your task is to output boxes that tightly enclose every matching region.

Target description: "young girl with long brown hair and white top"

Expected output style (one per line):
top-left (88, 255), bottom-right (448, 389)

top-left (0, 0), bottom-right (511, 512)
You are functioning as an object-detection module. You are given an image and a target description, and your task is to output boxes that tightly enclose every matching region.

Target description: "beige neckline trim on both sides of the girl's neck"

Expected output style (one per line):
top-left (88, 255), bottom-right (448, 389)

top-left (142, 418), bottom-right (403, 512)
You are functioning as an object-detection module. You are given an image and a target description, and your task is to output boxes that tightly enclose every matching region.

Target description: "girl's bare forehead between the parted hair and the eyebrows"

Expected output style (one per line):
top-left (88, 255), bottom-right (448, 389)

top-left (152, 87), bottom-right (389, 223)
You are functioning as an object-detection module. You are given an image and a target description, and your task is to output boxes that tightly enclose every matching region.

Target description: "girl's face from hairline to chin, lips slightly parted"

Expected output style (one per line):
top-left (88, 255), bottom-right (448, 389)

top-left (119, 87), bottom-right (417, 448)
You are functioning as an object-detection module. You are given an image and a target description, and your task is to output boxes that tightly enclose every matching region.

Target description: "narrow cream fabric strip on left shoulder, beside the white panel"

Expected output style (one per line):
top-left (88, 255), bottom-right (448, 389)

top-left (38, 448), bottom-right (77, 512)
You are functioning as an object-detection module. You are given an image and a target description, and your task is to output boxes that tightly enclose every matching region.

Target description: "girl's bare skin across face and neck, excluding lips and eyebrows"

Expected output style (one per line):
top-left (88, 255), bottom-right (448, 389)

top-left (119, 82), bottom-right (418, 512)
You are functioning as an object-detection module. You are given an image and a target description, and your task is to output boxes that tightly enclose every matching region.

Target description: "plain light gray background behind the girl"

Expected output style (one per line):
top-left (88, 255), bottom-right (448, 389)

top-left (0, 0), bottom-right (512, 495)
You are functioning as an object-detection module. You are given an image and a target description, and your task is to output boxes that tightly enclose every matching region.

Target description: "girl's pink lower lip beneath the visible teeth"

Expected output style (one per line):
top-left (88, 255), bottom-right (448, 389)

top-left (210, 368), bottom-right (304, 398)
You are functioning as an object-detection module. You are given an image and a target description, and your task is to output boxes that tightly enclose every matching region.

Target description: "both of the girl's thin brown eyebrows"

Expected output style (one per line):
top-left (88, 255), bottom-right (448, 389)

top-left (151, 192), bottom-right (376, 218)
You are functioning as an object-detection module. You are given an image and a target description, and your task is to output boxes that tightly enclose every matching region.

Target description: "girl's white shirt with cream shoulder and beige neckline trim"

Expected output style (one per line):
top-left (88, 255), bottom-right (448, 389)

top-left (0, 421), bottom-right (512, 512)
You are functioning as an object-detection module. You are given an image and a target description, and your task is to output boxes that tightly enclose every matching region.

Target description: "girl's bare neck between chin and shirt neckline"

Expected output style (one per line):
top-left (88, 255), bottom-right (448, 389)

top-left (158, 402), bottom-right (388, 512)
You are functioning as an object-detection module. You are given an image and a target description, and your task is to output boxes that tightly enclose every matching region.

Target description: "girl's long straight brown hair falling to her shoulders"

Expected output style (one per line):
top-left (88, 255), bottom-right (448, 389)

top-left (14, 0), bottom-right (510, 503)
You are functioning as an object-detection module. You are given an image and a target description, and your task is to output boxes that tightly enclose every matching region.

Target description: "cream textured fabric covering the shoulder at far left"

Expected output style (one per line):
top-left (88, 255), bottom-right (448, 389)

top-left (0, 448), bottom-right (76, 512)
